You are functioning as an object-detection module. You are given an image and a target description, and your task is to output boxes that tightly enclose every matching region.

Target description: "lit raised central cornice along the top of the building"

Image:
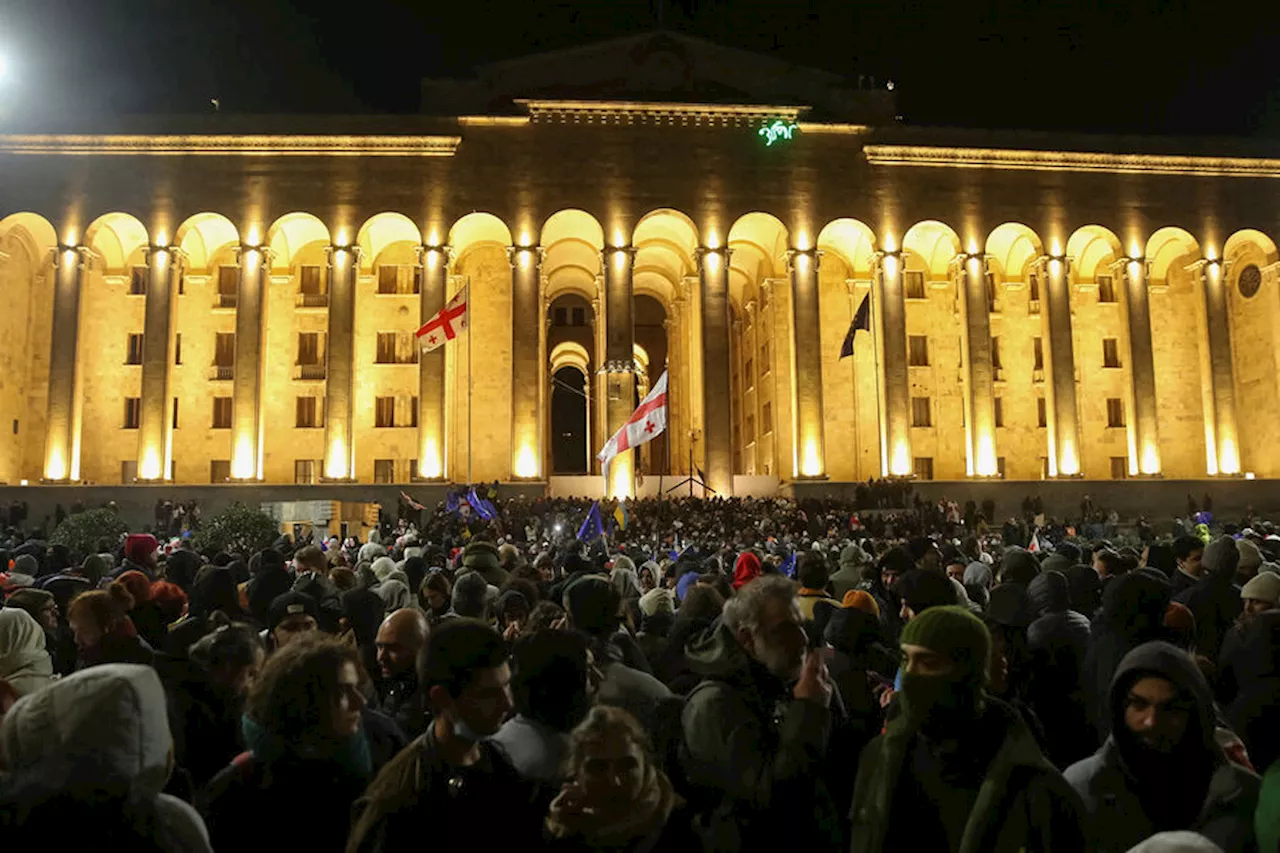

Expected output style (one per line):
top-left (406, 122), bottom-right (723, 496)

top-left (516, 99), bottom-right (809, 127)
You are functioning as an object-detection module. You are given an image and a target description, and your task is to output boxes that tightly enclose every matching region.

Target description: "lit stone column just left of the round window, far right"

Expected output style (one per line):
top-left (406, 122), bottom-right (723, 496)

top-left (1199, 260), bottom-right (1242, 475)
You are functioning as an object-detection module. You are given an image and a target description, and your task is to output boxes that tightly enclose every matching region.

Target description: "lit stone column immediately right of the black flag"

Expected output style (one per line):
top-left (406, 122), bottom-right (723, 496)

top-left (872, 252), bottom-right (914, 476)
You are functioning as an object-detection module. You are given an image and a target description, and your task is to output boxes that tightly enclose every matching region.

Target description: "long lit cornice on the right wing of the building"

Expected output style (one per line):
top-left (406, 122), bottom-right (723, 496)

top-left (863, 145), bottom-right (1280, 178)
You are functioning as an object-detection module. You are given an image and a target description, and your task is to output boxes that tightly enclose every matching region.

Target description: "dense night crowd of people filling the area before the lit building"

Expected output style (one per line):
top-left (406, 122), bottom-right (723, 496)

top-left (0, 493), bottom-right (1280, 853)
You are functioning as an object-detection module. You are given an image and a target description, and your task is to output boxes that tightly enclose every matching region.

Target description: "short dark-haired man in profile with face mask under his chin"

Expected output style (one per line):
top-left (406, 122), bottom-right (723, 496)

top-left (347, 619), bottom-right (547, 853)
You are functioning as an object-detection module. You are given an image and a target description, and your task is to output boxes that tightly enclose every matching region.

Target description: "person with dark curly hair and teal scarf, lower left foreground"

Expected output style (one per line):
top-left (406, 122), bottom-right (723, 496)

top-left (197, 638), bottom-right (404, 853)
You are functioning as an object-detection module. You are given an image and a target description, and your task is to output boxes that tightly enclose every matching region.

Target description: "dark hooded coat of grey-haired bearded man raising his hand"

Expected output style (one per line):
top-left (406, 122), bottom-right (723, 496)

top-left (681, 622), bottom-right (840, 853)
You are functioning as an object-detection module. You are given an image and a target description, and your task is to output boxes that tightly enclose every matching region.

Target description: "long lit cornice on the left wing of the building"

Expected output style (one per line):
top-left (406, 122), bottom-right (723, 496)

top-left (0, 134), bottom-right (462, 158)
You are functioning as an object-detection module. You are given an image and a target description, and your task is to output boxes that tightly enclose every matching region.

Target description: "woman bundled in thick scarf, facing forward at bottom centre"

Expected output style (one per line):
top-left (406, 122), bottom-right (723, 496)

top-left (545, 706), bottom-right (698, 853)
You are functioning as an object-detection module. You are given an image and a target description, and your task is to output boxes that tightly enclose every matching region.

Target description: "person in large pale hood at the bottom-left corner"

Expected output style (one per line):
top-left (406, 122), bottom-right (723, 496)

top-left (0, 663), bottom-right (210, 853)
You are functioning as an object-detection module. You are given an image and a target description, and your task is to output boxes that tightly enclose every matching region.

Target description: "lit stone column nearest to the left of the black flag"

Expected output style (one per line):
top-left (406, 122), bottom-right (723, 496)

top-left (787, 248), bottom-right (827, 479)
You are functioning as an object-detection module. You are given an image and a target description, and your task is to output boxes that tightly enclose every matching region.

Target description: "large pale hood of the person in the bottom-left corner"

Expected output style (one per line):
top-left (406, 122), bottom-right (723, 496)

top-left (0, 663), bottom-right (173, 795)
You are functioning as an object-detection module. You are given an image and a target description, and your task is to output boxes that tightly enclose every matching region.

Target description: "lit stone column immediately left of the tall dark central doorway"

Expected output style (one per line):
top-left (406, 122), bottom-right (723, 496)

top-left (507, 246), bottom-right (544, 480)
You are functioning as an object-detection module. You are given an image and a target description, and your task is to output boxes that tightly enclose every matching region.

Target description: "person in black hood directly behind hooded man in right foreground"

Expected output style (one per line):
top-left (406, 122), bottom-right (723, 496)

top-left (1082, 569), bottom-right (1171, 740)
